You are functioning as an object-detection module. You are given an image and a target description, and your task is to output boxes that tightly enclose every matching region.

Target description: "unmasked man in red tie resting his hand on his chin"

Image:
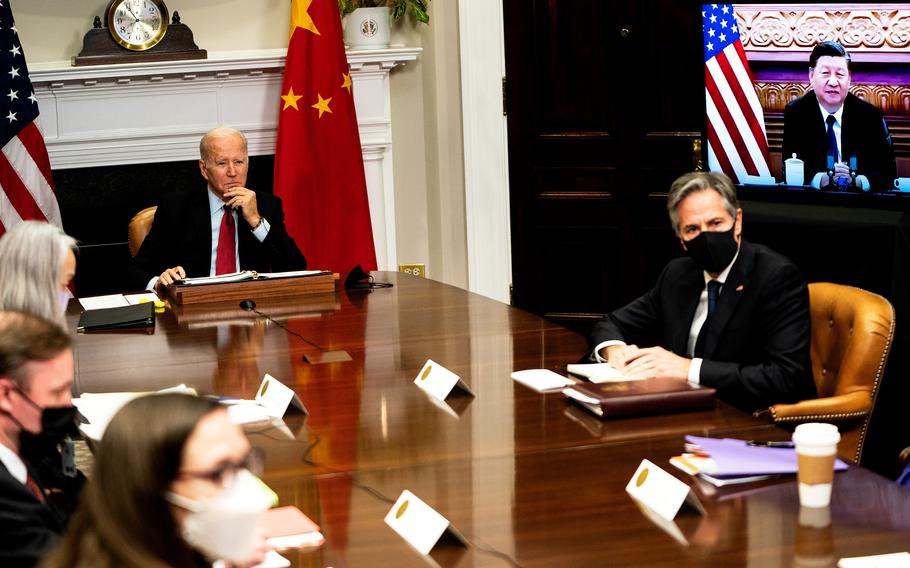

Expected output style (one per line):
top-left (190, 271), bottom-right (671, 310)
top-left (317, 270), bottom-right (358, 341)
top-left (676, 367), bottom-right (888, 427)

top-left (127, 127), bottom-right (306, 289)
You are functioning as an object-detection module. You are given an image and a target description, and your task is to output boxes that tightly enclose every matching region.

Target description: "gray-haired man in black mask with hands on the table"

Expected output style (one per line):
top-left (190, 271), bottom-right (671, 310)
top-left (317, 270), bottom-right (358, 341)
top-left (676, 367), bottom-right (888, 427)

top-left (590, 172), bottom-right (816, 411)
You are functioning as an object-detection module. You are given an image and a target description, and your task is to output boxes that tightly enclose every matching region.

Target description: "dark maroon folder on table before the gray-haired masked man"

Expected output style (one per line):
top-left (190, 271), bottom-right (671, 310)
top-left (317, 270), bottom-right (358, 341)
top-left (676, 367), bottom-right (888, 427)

top-left (563, 379), bottom-right (714, 418)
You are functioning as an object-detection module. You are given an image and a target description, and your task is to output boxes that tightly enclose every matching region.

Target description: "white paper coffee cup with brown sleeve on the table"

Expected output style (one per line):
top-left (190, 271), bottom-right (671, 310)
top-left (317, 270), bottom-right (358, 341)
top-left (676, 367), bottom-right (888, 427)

top-left (793, 422), bottom-right (840, 507)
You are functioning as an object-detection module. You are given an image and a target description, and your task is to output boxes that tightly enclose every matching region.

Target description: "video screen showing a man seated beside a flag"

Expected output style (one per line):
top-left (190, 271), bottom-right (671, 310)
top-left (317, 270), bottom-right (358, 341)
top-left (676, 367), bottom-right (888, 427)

top-left (702, 3), bottom-right (910, 194)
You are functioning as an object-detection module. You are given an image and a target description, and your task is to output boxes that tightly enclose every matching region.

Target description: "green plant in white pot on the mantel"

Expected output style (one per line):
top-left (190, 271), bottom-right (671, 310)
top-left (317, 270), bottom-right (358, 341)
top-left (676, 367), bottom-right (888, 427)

top-left (338, 0), bottom-right (430, 49)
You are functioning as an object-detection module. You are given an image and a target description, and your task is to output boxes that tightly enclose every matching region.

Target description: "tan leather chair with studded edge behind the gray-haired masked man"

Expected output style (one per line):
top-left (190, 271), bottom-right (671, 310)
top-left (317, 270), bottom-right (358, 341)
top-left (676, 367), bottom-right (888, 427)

top-left (769, 282), bottom-right (894, 463)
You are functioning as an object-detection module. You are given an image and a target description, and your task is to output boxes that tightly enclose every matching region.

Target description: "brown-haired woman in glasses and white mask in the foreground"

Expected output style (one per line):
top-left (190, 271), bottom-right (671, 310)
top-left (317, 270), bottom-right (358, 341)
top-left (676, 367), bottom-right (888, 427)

top-left (41, 394), bottom-right (271, 568)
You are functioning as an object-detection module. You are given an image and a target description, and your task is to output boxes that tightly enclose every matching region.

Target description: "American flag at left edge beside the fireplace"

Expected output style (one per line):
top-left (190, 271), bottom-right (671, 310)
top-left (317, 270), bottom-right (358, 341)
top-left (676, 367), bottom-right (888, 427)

top-left (0, 0), bottom-right (61, 235)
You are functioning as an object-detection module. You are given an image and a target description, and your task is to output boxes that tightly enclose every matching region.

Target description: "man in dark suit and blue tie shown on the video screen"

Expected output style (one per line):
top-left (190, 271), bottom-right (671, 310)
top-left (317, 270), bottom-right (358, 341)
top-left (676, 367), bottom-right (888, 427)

top-left (782, 41), bottom-right (897, 191)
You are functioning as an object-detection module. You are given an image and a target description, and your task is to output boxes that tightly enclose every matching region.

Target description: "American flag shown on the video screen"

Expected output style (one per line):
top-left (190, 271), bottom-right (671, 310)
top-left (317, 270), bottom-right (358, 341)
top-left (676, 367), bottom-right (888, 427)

top-left (701, 4), bottom-right (771, 182)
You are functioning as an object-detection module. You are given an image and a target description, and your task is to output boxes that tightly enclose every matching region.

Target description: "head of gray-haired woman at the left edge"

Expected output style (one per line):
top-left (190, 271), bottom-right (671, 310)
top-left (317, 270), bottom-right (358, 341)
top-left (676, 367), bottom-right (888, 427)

top-left (0, 221), bottom-right (76, 326)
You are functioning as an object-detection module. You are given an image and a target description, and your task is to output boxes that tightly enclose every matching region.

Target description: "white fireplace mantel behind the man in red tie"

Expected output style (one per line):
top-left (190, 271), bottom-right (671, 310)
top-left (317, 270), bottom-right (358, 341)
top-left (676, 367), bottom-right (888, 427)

top-left (30, 47), bottom-right (421, 270)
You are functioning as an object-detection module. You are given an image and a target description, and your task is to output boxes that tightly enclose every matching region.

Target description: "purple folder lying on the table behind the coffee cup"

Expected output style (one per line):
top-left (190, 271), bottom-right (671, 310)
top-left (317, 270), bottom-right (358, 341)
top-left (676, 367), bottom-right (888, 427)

top-left (686, 436), bottom-right (847, 477)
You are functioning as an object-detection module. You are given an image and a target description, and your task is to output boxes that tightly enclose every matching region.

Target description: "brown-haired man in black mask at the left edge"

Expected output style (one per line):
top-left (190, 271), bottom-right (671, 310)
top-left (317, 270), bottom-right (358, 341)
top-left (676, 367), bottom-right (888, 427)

top-left (0, 311), bottom-right (83, 566)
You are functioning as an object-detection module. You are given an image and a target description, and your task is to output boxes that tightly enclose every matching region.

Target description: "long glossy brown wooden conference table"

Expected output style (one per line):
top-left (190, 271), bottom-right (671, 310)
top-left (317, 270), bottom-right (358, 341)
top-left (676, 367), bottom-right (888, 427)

top-left (70, 272), bottom-right (910, 568)
